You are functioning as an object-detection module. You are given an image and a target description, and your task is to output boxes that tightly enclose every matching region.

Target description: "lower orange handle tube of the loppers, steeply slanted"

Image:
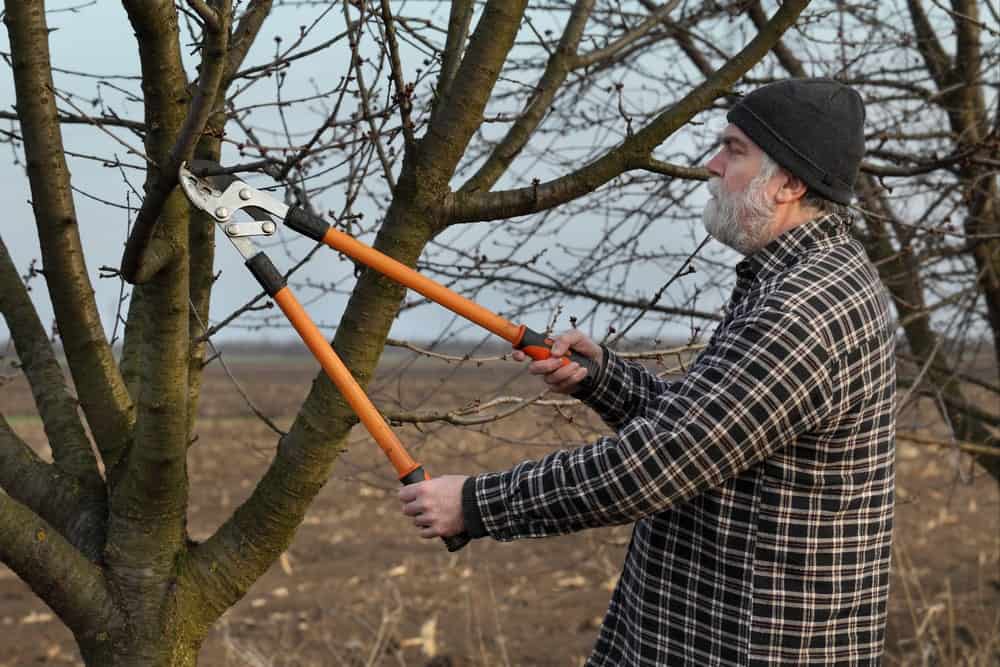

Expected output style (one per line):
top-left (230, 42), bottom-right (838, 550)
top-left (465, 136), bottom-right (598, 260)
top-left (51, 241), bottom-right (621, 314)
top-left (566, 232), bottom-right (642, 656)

top-left (273, 287), bottom-right (420, 479)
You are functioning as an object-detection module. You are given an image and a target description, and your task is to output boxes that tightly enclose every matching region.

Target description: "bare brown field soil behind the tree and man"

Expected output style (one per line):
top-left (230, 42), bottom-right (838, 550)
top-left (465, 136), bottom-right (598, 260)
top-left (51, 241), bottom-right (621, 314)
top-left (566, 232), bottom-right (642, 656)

top-left (0, 355), bottom-right (1000, 667)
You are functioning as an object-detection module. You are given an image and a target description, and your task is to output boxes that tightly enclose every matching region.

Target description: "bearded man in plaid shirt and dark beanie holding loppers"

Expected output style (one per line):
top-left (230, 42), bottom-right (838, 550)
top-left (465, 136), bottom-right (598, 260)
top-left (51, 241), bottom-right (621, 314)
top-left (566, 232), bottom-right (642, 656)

top-left (400, 79), bottom-right (895, 667)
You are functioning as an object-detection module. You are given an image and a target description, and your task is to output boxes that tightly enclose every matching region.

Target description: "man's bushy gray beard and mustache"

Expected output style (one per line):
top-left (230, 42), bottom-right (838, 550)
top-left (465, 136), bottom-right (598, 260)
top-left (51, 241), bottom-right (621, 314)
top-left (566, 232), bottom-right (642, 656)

top-left (702, 176), bottom-right (774, 255)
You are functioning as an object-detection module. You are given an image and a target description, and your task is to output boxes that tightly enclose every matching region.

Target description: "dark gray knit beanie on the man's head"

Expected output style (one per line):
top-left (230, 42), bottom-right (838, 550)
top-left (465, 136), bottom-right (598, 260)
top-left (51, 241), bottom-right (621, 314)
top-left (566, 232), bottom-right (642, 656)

top-left (727, 79), bottom-right (865, 204)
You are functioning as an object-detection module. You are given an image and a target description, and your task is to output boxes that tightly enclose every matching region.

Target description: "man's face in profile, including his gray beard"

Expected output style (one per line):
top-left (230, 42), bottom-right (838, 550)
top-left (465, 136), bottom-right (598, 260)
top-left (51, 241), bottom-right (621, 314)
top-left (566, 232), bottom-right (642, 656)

top-left (703, 125), bottom-right (776, 255)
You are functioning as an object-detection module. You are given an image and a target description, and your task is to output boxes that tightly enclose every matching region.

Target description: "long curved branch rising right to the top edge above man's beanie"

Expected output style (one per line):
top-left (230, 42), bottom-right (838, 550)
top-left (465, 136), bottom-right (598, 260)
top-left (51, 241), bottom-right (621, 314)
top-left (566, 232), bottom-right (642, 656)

top-left (446, 0), bottom-right (809, 223)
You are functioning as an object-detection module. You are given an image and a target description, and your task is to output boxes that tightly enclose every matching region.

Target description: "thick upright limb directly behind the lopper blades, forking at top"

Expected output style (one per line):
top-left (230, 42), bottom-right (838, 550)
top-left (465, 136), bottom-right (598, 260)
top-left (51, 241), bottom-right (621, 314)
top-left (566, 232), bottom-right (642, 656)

top-left (106, 0), bottom-right (232, 576)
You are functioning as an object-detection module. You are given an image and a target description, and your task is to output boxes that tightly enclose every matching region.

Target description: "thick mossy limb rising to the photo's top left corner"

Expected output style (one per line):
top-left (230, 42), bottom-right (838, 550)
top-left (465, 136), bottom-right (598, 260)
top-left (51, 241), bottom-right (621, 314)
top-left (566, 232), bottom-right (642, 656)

top-left (5, 0), bottom-right (134, 465)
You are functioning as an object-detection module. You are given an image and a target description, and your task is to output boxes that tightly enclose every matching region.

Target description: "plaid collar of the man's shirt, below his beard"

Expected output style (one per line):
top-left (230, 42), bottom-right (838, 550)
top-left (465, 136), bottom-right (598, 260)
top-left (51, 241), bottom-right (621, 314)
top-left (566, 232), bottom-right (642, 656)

top-left (736, 213), bottom-right (847, 280)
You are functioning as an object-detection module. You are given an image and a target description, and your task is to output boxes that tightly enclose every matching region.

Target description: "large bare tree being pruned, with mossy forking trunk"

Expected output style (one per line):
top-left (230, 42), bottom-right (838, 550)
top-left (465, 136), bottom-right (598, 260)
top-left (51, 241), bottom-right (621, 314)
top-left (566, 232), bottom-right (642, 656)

top-left (0, 0), bottom-right (808, 665)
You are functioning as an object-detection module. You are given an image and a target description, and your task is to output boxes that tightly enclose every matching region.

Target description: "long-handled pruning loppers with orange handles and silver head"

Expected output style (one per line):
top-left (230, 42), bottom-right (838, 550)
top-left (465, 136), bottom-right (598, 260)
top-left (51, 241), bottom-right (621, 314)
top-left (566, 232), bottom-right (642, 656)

top-left (178, 160), bottom-right (597, 551)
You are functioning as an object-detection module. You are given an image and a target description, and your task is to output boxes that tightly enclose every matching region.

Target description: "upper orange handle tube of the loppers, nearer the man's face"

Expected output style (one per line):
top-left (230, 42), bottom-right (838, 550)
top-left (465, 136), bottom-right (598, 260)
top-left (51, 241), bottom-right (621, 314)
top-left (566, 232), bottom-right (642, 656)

top-left (323, 227), bottom-right (523, 345)
